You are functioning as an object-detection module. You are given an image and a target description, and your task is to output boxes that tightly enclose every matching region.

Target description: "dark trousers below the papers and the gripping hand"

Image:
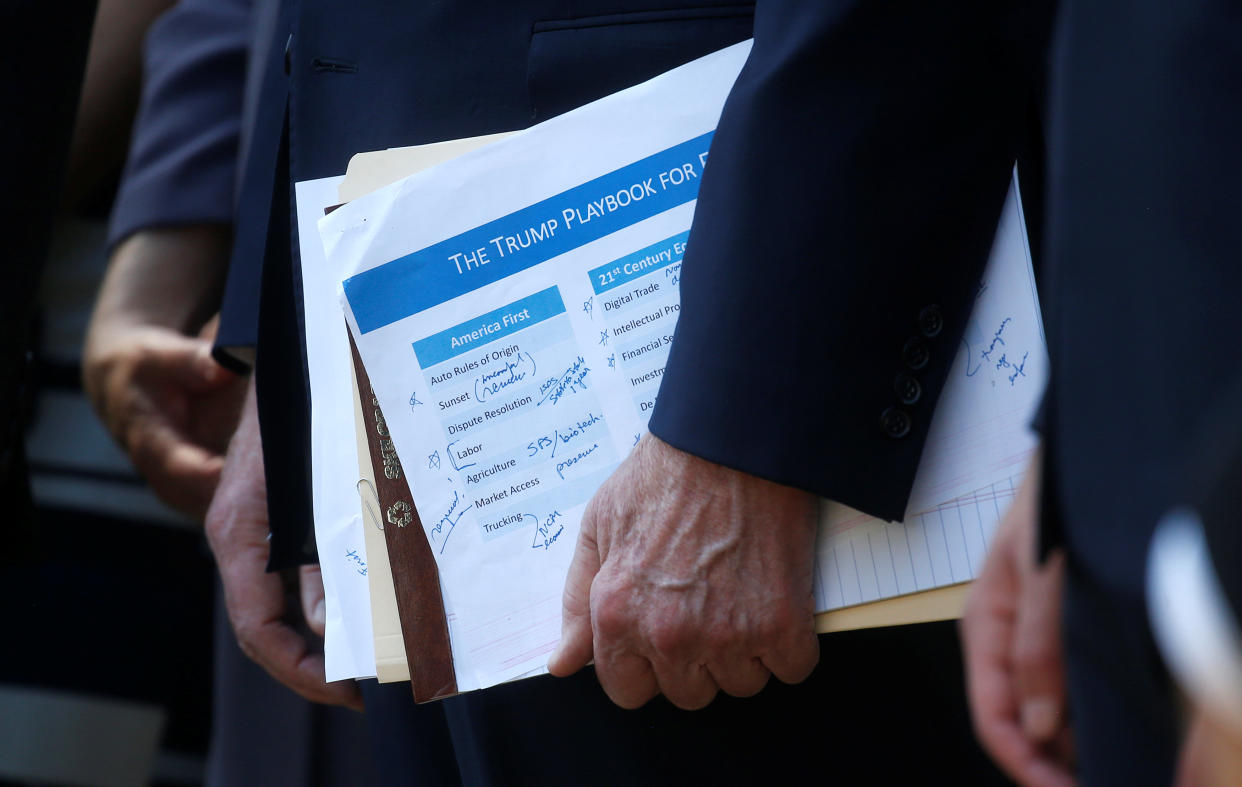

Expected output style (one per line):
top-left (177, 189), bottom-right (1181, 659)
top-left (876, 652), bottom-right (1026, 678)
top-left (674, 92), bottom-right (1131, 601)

top-left (368, 623), bottom-right (1006, 787)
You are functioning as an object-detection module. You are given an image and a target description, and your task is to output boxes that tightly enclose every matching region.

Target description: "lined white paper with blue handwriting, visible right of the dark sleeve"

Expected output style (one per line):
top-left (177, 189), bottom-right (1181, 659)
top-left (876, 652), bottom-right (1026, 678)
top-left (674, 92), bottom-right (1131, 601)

top-left (815, 175), bottom-right (1048, 611)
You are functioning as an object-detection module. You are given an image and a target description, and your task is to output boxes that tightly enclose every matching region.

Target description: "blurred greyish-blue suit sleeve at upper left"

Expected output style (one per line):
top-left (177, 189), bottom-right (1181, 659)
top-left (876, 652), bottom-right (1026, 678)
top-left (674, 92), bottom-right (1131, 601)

top-left (108, 0), bottom-right (250, 245)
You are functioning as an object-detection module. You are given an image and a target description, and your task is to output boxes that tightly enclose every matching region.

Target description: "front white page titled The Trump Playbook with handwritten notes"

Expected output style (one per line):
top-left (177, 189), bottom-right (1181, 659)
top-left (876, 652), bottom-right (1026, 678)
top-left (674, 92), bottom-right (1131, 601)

top-left (319, 43), bottom-right (1042, 690)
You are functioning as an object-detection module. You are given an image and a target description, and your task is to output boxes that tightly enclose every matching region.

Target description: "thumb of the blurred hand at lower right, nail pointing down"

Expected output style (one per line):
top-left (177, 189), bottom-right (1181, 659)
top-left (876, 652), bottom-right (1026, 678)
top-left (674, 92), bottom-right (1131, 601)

top-left (1013, 552), bottom-right (1067, 744)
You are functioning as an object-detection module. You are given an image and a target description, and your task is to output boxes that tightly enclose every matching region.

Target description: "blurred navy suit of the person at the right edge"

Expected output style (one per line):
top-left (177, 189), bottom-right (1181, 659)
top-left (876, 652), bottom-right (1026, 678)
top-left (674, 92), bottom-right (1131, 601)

top-left (1043, 0), bottom-right (1242, 785)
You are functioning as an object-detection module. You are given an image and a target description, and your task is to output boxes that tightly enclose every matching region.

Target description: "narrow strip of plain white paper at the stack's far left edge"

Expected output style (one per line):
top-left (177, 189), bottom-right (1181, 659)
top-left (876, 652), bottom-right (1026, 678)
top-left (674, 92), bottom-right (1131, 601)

top-left (294, 176), bottom-right (375, 680)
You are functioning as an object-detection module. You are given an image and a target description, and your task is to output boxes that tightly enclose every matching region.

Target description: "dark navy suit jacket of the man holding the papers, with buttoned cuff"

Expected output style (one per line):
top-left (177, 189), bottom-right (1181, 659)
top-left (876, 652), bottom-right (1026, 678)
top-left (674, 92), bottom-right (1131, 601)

top-left (222, 0), bottom-right (1046, 565)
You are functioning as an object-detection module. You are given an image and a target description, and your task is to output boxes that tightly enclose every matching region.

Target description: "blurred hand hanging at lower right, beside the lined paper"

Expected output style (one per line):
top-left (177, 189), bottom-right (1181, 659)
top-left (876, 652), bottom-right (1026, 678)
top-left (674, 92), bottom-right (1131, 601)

top-left (961, 453), bottom-right (1074, 787)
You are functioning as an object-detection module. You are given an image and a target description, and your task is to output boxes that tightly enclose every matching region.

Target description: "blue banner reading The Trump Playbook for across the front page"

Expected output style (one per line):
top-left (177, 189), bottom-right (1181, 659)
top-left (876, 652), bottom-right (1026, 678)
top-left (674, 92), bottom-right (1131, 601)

top-left (344, 132), bottom-right (714, 334)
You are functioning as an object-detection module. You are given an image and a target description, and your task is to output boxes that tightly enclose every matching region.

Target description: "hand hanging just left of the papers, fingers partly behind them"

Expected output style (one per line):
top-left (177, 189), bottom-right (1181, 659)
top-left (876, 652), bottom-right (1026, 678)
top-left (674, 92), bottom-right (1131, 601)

top-left (206, 384), bottom-right (361, 710)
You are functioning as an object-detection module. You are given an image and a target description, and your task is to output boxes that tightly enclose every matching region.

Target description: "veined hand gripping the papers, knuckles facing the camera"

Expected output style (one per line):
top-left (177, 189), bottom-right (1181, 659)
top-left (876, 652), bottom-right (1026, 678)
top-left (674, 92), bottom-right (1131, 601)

top-left (548, 434), bottom-right (820, 709)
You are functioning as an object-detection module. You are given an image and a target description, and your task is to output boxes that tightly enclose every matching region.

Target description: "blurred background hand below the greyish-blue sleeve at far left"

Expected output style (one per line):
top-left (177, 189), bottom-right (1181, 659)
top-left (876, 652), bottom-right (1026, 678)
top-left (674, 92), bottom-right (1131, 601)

top-left (82, 227), bottom-right (245, 520)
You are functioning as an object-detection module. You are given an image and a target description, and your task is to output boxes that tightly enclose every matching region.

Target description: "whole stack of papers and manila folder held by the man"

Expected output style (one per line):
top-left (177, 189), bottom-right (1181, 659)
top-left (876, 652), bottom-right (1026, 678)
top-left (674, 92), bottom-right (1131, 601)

top-left (297, 43), bottom-right (1047, 696)
